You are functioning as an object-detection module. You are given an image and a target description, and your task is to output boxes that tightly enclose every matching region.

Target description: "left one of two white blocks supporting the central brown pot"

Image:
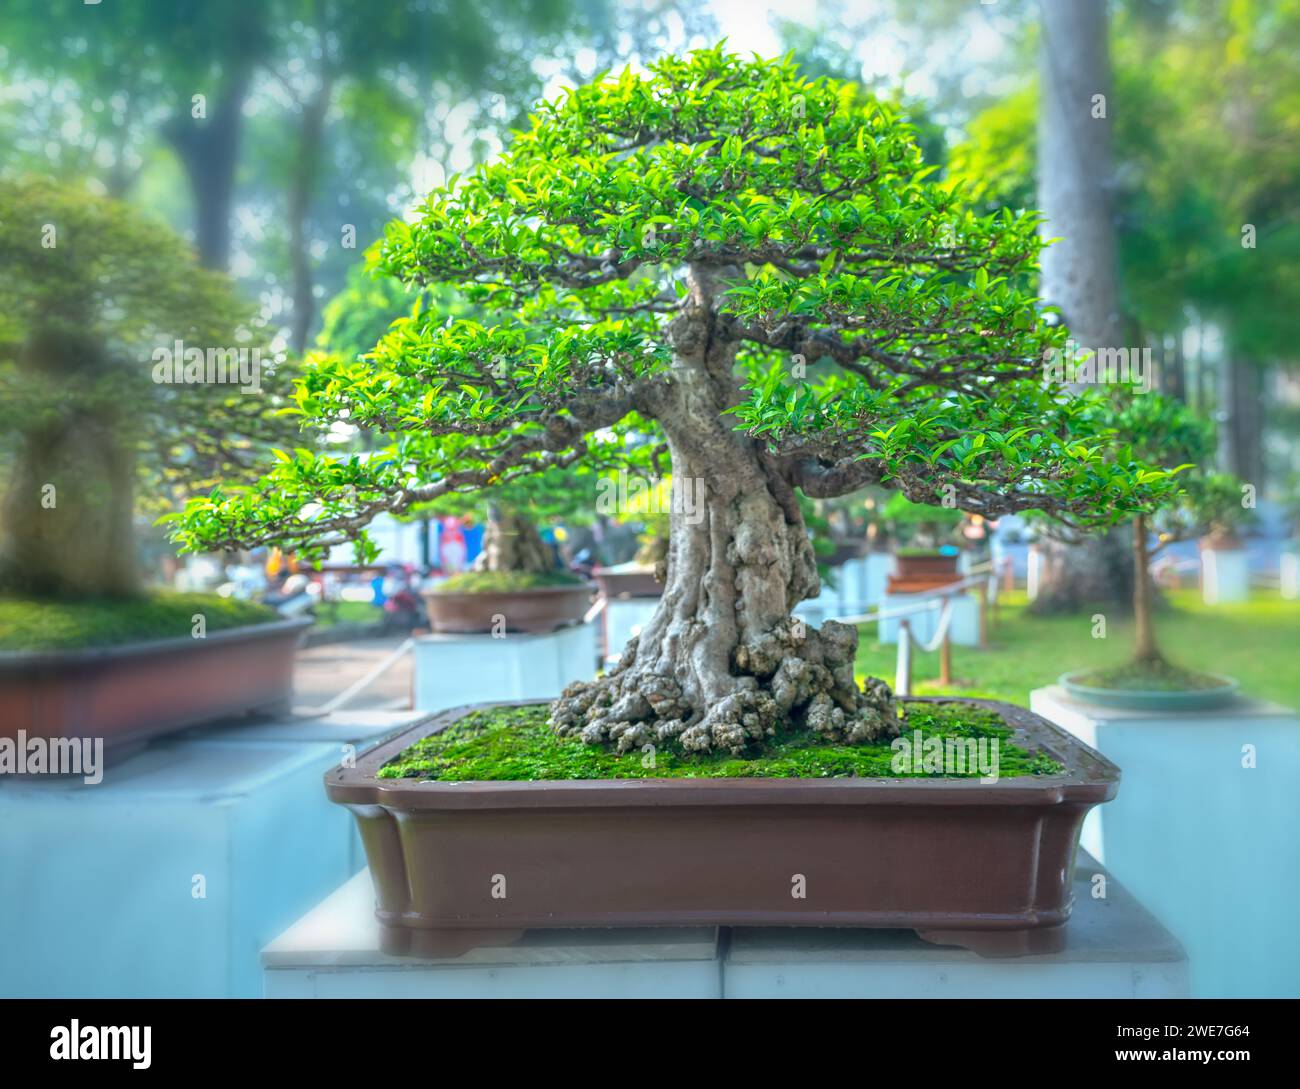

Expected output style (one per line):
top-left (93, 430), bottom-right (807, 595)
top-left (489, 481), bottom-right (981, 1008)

top-left (263, 871), bottom-right (722, 998)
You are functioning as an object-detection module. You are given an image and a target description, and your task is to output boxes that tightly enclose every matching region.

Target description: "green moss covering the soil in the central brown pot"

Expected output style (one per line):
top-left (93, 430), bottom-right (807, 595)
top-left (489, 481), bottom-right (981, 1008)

top-left (378, 703), bottom-right (1061, 782)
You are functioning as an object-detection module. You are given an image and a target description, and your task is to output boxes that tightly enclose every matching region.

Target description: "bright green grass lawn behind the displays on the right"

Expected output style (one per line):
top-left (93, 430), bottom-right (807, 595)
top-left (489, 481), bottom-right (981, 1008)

top-left (857, 590), bottom-right (1300, 707)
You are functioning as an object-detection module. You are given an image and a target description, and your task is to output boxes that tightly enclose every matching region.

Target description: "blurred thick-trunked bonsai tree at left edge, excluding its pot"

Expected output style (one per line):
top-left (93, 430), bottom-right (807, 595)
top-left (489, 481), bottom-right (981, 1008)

top-left (0, 181), bottom-right (296, 596)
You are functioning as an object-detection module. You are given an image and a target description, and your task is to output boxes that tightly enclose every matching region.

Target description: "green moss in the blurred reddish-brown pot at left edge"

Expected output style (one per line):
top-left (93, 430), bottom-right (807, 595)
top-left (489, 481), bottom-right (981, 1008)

top-left (0, 593), bottom-right (280, 651)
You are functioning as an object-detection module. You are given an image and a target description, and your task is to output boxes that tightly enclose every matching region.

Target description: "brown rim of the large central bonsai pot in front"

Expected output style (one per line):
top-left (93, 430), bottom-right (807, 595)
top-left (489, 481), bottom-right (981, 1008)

top-left (325, 697), bottom-right (1119, 811)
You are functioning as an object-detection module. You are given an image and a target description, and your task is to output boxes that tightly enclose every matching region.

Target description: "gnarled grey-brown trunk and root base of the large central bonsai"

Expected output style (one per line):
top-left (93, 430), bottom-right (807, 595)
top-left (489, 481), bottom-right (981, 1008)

top-left (551, 296), bottom-right (898, 752)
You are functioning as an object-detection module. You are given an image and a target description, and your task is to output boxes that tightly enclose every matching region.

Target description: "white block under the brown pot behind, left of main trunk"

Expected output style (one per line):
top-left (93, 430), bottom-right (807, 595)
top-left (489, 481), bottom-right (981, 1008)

top-left (412, 622), bottom-right (598, 711)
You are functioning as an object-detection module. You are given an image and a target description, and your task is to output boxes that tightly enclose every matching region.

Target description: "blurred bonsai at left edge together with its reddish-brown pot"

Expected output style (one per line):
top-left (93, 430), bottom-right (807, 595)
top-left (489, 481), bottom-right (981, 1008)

top-left (0, 181), bottom-right (309, 772)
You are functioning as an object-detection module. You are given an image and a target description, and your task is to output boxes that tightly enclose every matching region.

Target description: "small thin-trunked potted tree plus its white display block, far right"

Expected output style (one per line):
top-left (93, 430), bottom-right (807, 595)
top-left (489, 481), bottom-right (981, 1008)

top-left (1031, 392), bottom-right (1300, 997)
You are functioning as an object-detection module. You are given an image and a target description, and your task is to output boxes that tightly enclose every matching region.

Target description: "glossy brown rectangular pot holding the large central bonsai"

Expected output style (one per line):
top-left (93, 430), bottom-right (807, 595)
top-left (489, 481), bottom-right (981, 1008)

top-left (325, 700), bottom-right (1119, 956)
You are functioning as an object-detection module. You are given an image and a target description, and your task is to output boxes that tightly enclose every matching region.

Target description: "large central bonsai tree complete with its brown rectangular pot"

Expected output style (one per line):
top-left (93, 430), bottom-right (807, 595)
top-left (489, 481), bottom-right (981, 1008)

top-left (181, 49), bottom-right (1190, 954)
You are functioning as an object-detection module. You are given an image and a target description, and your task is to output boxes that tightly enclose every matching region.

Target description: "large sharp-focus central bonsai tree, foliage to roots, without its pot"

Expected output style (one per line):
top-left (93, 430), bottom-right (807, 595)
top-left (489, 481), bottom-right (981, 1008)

top-left (181, 49), bottom-right (1173, 752)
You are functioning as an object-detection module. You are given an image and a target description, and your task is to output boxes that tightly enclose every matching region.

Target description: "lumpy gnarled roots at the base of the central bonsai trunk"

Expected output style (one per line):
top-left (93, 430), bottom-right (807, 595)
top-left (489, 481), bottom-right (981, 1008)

top-left (551, 617), bottom-right (901, 755)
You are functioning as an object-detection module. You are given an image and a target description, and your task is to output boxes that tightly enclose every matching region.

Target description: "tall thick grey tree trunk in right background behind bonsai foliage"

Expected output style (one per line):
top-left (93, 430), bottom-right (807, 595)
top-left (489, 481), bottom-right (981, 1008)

top-left (1034, 0), bottom-right (1132, 612)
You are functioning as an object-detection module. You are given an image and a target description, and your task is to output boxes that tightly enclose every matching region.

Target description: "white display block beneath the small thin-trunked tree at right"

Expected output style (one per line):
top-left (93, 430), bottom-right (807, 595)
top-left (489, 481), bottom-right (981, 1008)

top-left (1030, 685), bottom-right (1300, 998)
